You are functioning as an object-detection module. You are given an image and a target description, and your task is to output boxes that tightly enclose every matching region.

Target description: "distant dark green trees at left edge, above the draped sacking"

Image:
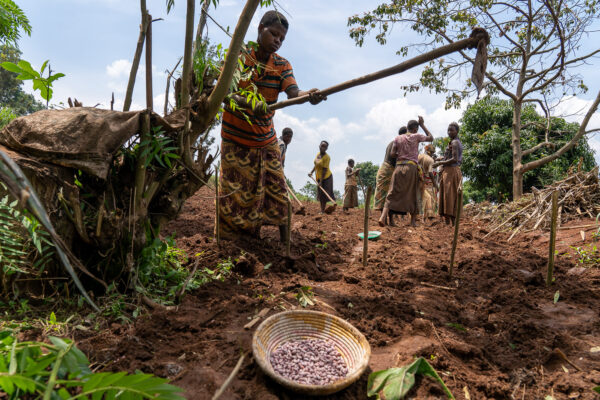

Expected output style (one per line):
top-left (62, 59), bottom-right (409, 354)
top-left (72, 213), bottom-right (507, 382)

top-left (0, 45), bottom-right (45, 116)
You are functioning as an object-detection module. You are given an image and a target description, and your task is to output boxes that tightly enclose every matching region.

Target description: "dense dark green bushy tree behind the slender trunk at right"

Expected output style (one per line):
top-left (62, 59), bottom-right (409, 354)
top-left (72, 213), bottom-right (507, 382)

top-left (460, 97), bottom-right (596, 202)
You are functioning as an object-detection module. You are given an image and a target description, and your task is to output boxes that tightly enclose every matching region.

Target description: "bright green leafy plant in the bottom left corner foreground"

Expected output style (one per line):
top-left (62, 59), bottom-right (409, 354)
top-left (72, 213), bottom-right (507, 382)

top-left (0, 330), bottom-right (184, 400)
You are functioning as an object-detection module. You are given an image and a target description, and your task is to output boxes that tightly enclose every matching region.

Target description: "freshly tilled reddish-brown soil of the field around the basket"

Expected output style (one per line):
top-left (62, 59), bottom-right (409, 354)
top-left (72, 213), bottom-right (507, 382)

top-left (77, 190), bottom-right (600, 400)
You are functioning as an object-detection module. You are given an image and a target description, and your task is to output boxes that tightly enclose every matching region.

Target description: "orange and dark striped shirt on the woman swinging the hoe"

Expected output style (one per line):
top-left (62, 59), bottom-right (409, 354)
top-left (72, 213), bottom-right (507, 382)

top-left (221, 50), bottom-right (298, 147)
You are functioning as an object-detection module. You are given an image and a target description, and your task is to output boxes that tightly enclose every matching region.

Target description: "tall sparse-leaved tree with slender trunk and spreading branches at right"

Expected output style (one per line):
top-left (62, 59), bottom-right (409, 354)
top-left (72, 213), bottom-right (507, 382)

top-left (348, 0), bottom-right (600, 198)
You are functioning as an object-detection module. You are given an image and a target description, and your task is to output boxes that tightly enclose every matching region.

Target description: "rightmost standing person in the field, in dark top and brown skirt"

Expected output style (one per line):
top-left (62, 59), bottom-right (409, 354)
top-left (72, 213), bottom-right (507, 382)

top-left (433, 122), bottom-right (463, 225)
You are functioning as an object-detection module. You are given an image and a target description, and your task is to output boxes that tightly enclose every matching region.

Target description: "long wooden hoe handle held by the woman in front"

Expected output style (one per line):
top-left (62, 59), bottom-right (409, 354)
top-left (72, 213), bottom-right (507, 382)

top-left (269, 30), bottom-right (488, 111)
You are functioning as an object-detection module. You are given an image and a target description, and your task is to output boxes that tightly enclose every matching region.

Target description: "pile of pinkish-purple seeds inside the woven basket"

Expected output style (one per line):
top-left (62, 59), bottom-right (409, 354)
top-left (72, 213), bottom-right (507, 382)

top-left (270, 339), bottom-right (348, 385)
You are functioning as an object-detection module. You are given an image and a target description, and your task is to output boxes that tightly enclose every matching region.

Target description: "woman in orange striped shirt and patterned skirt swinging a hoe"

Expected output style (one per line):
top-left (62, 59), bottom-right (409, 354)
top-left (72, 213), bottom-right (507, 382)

top-left (218, 11), bottom-right (325, 241)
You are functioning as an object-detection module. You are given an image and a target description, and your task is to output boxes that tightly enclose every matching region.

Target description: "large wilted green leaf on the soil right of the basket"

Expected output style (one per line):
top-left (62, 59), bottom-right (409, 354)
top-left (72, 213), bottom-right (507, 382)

top-left (367, 357), bottom-right (454, 400)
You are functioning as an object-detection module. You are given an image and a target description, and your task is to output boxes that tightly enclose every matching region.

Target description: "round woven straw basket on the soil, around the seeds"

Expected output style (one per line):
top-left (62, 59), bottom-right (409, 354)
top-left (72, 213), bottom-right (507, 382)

top-left (252, 310), bottom-right (371, 395)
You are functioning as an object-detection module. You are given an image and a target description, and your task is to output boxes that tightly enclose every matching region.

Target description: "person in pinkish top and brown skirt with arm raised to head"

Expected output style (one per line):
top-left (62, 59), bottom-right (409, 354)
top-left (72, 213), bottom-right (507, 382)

top-left (379, 116), bottom-right (433, 226)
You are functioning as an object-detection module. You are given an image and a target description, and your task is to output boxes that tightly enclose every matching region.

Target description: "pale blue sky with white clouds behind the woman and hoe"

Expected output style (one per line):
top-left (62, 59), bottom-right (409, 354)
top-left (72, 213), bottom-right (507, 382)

top-left (18, 0), bottom-right (600, 194)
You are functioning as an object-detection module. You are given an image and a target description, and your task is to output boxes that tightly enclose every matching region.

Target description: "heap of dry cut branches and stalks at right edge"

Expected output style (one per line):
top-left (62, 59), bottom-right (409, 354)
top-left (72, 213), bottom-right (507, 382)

top-left (474, 167), bottom-right (600, 236)
